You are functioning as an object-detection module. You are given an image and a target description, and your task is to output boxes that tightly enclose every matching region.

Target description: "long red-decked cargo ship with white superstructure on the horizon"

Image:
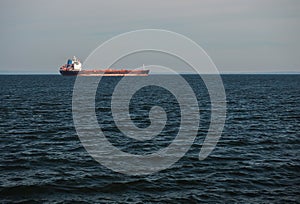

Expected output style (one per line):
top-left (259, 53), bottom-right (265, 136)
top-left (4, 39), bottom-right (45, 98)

top-left (59, 56), bottom-right (149, 76)
